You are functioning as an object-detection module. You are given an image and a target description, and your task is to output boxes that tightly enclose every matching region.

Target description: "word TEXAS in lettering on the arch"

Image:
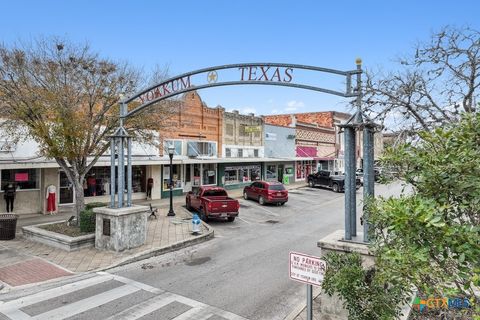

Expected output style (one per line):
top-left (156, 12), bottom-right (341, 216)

top-left (238, 66), bottom-right (293, 82)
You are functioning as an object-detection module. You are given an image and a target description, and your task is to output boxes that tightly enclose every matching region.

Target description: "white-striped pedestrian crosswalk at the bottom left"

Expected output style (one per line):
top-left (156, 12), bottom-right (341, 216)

top-left (0, 272), bottom-right (247, 320)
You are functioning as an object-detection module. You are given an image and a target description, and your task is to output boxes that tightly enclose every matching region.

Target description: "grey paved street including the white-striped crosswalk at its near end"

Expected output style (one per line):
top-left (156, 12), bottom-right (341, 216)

top-left (0, 185), bottom-right (400, 320)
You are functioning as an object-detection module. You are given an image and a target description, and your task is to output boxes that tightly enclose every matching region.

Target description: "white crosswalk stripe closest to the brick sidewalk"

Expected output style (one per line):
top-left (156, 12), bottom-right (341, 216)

top-left (0, 274), bottom-right (113, 310)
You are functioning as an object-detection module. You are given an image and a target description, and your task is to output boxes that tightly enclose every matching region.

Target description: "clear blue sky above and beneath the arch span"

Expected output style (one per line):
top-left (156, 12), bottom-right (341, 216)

top-left (0, 0), bottom-right (480, 114)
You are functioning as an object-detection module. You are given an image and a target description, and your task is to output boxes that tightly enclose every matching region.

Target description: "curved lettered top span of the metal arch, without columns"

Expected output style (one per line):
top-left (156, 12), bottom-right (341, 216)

top-left (120, 63), bottom-right (362, 119)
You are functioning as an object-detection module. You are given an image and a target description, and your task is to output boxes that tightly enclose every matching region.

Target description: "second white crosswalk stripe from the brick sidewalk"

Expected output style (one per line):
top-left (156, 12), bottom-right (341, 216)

top-left (35, 285), bottom-right (140, 320)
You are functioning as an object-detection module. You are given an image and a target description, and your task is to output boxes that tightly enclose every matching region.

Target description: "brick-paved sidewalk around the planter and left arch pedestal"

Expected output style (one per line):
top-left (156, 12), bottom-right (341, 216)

top-left (0, 181), bottom-right (305, 292)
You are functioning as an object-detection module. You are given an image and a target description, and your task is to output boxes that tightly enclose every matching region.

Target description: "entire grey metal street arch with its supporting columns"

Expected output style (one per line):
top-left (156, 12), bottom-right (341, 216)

top-left (110, 59), bottom-right (375, 242)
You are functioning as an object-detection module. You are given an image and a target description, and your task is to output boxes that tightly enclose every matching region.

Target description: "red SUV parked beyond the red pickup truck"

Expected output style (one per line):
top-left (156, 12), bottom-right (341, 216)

top-left (243, 181), bottom-right (288, 206)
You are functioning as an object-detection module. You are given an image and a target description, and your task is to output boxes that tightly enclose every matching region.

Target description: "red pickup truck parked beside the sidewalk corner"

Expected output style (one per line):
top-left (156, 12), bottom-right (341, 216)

top-left (185, 187), bottom-right (240, 222)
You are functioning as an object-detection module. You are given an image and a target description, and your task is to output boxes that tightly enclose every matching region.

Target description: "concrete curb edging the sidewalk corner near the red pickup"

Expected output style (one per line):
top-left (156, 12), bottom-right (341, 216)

top-left (97, 207), bottom-right (214, 273)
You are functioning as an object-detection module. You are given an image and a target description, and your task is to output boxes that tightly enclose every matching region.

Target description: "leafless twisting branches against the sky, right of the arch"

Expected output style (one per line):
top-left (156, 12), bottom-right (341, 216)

top-left (364, 27), bottom-right (480, 134)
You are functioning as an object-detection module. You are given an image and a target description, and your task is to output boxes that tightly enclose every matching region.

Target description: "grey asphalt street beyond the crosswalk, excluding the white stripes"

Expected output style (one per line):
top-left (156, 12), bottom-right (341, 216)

top-left (110, 185), bottom-right (400, 319)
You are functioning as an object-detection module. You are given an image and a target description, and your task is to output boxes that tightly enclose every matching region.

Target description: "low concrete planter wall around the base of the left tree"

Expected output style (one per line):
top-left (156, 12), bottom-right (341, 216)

top-left (22, 221), bottom-right (95, 251)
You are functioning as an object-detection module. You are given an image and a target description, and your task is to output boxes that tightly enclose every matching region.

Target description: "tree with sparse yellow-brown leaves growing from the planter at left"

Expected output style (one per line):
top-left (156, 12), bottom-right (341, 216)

top-left (0, 38), bottom-right (175, 218)
